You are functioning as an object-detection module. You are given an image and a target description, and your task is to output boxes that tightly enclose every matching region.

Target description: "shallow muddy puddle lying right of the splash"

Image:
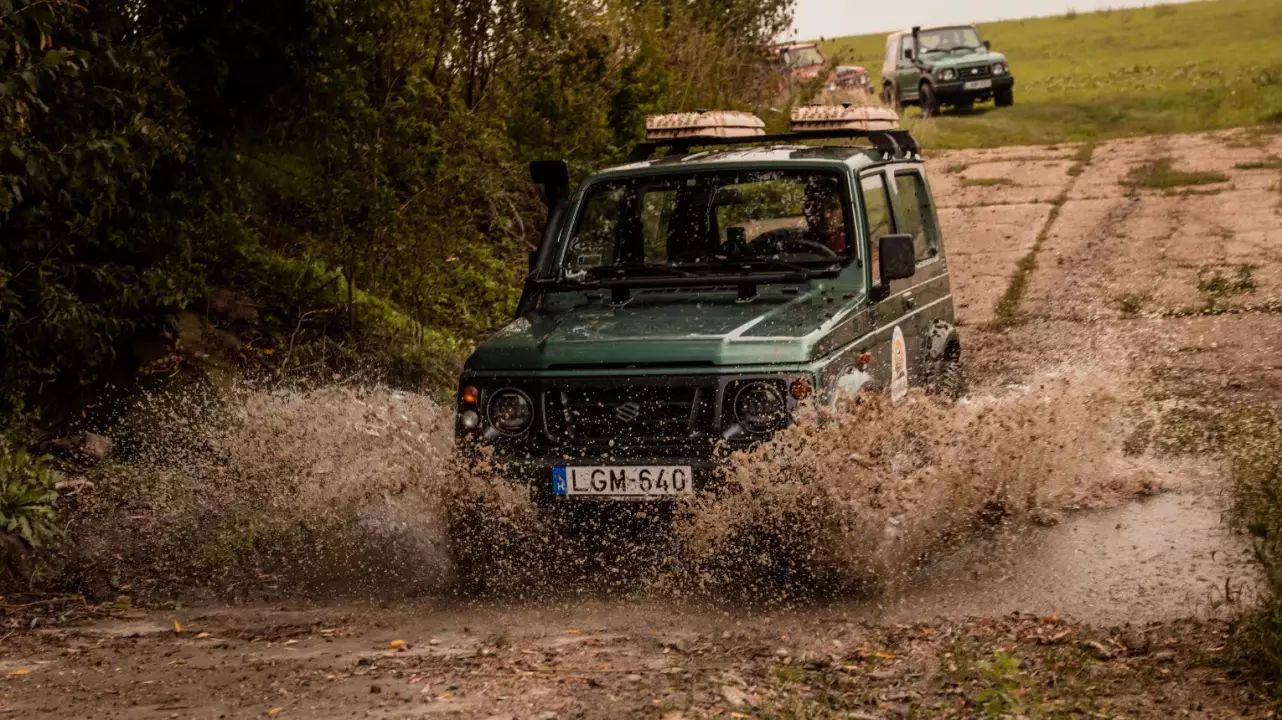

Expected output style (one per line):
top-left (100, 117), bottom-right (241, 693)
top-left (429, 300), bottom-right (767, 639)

top-left (855, 493), bottom-right (1261, 625)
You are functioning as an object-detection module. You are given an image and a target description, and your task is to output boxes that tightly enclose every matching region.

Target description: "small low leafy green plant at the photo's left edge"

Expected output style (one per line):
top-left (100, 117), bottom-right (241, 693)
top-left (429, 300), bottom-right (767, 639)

top-left (0, 441), bottom-right (58, 547)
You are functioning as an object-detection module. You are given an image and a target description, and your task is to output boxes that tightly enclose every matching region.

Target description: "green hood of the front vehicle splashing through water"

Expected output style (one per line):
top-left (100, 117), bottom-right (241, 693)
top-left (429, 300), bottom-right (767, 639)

top-left (467, 287), bottom-right (858, 370)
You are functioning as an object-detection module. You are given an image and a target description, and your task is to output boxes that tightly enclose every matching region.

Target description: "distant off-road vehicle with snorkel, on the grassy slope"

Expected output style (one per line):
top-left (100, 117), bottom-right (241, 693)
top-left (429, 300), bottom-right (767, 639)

top-left (882, 26), bottom-right (1015, 118)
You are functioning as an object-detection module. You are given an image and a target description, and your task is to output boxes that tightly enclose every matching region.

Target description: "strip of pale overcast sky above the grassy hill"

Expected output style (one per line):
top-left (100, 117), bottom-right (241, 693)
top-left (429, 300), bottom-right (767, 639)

top-left (794, 0), bottom-right (1199, 40)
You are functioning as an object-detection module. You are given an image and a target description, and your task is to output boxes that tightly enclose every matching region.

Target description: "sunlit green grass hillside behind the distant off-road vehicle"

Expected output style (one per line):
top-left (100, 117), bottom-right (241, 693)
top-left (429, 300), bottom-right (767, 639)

top-left (822, 0), bottom-right (1282, 147)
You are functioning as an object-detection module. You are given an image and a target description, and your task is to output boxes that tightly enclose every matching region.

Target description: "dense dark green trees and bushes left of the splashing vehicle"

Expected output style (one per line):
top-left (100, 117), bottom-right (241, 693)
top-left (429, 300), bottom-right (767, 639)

top-left (0, 0), bottom-right (792, 423)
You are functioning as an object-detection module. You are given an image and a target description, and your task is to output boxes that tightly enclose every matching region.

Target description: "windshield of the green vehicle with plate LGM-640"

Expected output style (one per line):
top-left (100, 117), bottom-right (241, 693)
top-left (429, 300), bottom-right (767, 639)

top-left (562, 170), bottom-right (853, 277)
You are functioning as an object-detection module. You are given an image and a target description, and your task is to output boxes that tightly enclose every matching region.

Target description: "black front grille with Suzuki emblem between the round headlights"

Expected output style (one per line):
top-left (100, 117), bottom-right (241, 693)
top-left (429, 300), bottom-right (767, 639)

top-left (546, 386), bottom-right (713, 443)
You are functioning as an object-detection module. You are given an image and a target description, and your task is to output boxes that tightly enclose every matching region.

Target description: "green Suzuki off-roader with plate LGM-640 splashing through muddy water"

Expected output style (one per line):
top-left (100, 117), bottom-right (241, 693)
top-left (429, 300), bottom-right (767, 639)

top-left (455, 106), bottom-right (960, 501)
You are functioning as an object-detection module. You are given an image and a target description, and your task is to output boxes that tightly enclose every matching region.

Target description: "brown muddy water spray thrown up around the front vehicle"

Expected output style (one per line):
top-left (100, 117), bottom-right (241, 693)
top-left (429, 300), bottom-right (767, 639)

top-left (64, 361), bottom-right (1165, 605)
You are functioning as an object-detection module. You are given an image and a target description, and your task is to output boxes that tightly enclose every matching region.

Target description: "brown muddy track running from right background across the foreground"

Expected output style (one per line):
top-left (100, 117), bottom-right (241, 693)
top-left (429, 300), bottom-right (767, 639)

top-left (0, 131), bottom-right (1282, 720)
